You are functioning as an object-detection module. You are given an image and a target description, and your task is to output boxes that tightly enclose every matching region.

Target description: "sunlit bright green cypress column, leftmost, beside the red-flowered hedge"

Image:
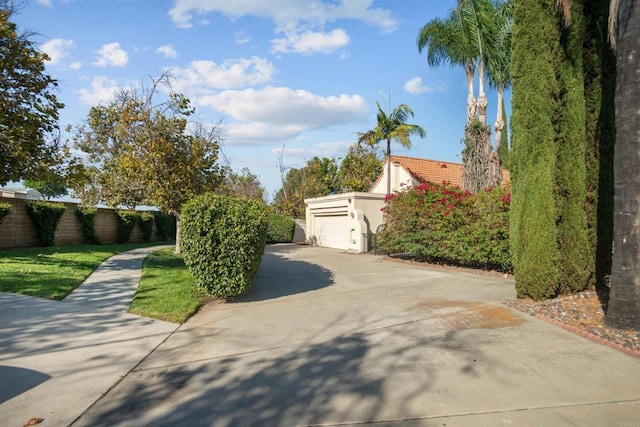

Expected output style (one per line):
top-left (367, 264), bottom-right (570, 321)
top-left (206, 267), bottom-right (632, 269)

top-left (510, 0), bottom-right (560, 299)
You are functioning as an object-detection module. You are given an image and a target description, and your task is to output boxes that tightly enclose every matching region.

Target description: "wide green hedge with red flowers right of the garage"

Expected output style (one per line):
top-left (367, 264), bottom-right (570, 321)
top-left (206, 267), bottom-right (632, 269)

top-left (378, 183), bottom-right (511, 271)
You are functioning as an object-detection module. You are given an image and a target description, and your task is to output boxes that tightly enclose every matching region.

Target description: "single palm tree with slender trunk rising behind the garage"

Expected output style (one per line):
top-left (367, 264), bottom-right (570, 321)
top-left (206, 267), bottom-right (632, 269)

top-left (358, 101), bottom-right (427, 195)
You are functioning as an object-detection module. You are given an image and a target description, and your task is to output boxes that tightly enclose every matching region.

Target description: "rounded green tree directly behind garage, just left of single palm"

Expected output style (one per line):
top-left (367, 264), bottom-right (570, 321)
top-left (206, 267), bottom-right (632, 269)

top-left (338, 143), bottom-right (382, 192)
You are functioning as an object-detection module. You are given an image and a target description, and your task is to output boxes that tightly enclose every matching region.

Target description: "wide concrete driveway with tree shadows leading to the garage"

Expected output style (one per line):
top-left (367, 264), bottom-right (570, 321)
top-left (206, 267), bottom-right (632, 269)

top-left (74, 245), bottom-right (640, 427)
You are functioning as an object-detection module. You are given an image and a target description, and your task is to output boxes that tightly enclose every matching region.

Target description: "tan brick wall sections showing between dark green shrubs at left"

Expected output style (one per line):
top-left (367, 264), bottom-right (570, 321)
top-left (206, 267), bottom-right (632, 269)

top-left (0, 197), bottom-right (168, 249)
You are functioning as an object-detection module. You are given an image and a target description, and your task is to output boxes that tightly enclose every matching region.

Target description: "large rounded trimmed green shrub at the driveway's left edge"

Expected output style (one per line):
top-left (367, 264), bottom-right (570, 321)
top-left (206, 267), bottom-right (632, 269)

top-left (180, 193), bottom-right (267, 298)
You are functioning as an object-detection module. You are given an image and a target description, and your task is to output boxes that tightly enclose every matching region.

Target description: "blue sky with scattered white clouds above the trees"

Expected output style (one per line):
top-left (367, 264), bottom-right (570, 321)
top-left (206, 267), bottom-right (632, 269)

top-left (13, 0), bottom-right (509, 201)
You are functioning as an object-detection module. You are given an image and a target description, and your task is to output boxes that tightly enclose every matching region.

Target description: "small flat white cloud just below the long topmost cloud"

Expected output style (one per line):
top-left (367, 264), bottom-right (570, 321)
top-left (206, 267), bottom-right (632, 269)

top-left (271, 28), bottom-right (349, 54)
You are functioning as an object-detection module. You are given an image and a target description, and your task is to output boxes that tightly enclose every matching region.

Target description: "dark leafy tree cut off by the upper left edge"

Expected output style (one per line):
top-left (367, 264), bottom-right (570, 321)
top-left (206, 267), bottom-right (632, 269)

top-left (0, 0), bottom-right (64, 185)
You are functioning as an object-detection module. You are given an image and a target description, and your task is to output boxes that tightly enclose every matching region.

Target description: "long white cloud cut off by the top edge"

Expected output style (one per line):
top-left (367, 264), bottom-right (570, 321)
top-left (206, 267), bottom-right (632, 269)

top-left (169, 0), bottom-right (399, 33)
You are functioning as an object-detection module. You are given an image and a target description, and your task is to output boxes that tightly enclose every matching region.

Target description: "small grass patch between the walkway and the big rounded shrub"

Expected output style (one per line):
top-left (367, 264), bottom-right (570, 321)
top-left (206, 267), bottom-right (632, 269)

top-left (129, 248), bottom-right (207, 323)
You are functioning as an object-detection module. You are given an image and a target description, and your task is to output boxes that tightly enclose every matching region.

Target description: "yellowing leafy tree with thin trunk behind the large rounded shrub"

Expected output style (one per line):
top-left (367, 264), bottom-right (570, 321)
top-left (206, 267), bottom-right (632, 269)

top-left (74, 75), bottom-right (222, 252)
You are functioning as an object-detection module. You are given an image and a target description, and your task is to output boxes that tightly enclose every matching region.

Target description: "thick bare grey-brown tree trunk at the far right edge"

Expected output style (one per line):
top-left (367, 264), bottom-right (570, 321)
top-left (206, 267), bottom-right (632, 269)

top-left (604, 0), bottom-right (640, 331)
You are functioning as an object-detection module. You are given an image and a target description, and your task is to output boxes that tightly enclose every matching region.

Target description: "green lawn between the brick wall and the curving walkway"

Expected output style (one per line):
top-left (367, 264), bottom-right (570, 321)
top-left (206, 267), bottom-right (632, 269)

top-left (0, 242), bottom-right (165, 300)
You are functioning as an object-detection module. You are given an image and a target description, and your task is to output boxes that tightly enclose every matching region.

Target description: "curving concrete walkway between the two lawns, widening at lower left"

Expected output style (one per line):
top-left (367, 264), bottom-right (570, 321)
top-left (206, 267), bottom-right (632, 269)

top-left (0, 247), bottom-right (178, 427)
